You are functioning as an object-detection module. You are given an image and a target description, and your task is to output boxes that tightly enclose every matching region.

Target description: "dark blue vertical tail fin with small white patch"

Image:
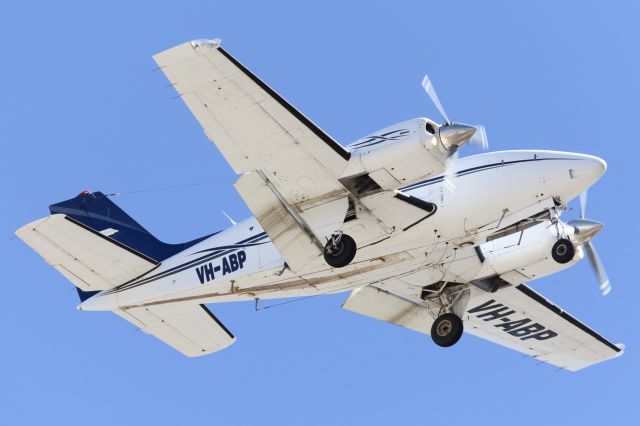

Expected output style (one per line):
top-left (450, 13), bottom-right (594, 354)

top-left (49, 191), bottom-right (210, 262)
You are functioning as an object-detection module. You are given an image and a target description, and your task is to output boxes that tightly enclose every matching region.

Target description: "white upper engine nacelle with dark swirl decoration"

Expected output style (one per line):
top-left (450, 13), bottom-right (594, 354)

top-left (342, 118), bottom-right (449, 190)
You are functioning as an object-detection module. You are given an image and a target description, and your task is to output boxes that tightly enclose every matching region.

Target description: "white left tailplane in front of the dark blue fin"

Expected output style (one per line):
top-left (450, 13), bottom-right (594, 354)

top-left (16, 214), bottom-right (157, 291)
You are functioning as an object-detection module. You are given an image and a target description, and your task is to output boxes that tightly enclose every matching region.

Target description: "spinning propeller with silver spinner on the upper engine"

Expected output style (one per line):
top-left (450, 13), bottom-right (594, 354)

top-left (422, 75), bottom-right (489, 193)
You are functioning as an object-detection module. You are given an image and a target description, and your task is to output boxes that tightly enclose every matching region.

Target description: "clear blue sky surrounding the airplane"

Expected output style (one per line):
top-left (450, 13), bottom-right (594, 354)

top-left (0, 0), bottom-right (640, 425)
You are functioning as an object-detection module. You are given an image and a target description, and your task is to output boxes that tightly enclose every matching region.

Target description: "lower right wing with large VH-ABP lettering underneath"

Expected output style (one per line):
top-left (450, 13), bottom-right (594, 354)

top-left (342, 283), bottom-right (622, 371)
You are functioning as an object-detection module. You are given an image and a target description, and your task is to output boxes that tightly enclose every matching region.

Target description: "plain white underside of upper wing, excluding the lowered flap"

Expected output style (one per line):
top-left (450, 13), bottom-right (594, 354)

top-left (154, 42), bottom-right (349, 205)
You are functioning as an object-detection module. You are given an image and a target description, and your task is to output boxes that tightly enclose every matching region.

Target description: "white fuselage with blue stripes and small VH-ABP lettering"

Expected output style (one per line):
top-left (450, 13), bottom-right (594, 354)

top-left (80, 151), bottom-right (606, 310)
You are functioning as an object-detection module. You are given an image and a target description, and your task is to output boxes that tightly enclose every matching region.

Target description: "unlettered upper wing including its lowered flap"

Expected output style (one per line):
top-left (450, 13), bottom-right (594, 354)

top-left (154, 40), bottom-right (350, 272)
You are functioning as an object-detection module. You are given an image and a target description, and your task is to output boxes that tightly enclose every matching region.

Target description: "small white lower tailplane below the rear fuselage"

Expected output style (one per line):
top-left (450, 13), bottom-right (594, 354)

top-left (114, 303), bottom-right (236, 357)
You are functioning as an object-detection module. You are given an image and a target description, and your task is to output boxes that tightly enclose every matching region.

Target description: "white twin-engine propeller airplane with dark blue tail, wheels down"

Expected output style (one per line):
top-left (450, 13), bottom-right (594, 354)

top-left (16, 39), bottom-right (624, 371)
